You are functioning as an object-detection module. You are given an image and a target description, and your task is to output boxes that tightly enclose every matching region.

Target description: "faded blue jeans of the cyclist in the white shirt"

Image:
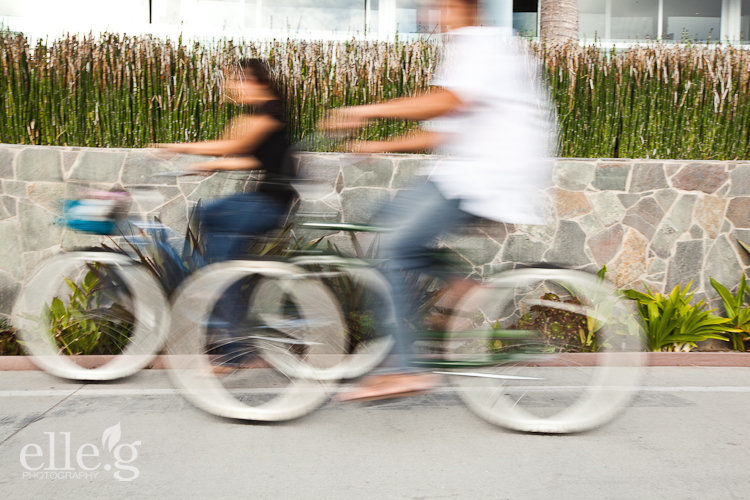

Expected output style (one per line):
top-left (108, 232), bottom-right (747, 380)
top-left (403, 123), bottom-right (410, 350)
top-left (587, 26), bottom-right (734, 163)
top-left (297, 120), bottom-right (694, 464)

top-left (376, 181), bottom-right (473, 372)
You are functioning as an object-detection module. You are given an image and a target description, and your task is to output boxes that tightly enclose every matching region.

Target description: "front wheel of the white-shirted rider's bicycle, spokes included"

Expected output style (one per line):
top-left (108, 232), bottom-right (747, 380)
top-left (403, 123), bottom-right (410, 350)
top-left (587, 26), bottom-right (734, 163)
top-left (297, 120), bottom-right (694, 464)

top-left (167, 261), bottom-right (346, 421)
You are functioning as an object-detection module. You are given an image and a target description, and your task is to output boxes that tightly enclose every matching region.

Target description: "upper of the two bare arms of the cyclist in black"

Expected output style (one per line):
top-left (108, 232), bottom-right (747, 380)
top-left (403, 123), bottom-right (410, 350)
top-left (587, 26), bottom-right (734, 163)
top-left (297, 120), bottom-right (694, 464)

top-left (156, 115), bottom-right (283, 156)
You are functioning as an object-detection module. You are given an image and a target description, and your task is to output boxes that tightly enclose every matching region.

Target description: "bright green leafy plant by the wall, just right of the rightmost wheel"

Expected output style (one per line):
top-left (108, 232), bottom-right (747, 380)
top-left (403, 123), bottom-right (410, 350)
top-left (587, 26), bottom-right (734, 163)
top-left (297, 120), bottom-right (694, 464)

top-left (623, 282), bottom-right (736, 351)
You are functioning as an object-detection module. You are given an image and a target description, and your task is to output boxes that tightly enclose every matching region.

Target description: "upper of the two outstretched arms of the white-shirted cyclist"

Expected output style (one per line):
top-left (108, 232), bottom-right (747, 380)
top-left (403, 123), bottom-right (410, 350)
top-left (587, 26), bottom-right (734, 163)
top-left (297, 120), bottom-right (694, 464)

top-left (323, 88), bottom-right (463, 130)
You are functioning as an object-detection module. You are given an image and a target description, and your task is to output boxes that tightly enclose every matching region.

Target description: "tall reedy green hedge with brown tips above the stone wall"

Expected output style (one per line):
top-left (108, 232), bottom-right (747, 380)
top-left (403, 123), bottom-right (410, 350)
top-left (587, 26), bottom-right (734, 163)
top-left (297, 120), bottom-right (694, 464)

top-left (0, 32), bottom-right (750, 159)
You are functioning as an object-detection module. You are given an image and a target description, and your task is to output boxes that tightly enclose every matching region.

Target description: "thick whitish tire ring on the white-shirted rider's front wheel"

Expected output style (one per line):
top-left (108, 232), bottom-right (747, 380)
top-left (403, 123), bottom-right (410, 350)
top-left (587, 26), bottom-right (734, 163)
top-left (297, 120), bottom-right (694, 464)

top-left (167, 261), bottom-right (345, 422)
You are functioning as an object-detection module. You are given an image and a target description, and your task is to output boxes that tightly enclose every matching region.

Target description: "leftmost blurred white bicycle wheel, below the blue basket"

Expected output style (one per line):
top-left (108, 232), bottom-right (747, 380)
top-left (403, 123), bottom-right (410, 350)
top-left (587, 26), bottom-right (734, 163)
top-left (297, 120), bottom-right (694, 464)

top-left (13, 251), bottom-right (169, 380)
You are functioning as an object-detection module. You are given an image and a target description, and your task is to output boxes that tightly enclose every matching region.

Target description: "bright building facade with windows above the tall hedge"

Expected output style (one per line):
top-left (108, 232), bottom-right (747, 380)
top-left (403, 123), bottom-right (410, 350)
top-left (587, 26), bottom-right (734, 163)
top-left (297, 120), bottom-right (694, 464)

top-left (0, 0), bottom-right (750, 43)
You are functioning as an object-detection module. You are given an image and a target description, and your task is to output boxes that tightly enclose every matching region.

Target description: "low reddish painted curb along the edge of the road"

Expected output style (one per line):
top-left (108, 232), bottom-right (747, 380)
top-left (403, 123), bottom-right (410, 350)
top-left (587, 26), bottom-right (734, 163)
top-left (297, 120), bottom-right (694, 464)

top-left (0, 352), bottom-right (750, 371)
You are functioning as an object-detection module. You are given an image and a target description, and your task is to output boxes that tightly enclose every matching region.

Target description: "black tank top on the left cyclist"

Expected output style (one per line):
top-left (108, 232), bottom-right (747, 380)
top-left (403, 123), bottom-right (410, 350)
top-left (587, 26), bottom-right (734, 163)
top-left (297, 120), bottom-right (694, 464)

top-left (245, 100), bottom-right (297, 205)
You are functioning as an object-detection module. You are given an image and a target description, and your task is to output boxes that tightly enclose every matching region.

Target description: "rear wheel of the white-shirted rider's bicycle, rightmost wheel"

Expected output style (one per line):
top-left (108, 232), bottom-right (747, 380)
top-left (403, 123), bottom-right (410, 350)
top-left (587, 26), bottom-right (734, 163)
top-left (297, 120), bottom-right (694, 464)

top-left (445, 268), bottom-right (645, 433)
